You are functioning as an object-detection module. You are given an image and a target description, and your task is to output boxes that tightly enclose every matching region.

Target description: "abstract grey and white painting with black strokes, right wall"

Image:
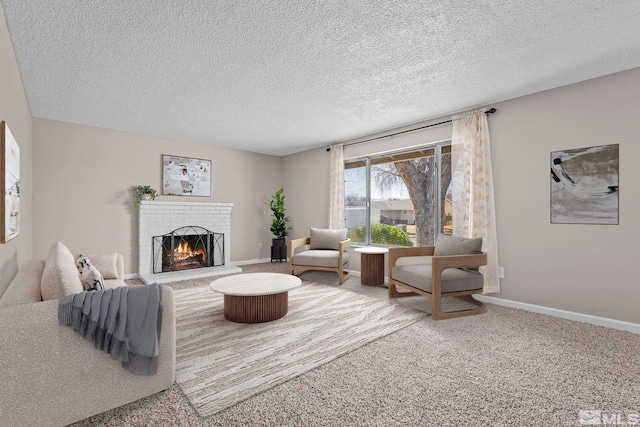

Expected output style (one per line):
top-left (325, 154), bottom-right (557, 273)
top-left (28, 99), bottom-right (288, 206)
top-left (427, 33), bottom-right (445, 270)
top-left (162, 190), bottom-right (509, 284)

top-left (551, 144), bottom-right (619, 224)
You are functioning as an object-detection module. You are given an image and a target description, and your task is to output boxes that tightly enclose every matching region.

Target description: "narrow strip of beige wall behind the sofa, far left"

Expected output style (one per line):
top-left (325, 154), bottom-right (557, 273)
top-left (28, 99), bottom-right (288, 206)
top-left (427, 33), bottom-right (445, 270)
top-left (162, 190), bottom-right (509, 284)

top-left (0, 4), bottom-right (32, 295)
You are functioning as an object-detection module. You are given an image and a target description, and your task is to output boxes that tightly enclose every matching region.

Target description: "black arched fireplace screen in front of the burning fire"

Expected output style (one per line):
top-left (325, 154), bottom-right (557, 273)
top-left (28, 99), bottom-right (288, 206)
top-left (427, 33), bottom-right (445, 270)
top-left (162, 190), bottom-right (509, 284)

top-left (152, 225), bottom-right (224, 273)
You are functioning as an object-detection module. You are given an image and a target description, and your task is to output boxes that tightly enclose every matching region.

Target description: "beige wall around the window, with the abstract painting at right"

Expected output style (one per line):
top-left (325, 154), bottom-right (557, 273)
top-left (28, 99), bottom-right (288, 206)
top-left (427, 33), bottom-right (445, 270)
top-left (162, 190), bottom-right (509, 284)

top-left (284, 69), bottom-right (640, 323)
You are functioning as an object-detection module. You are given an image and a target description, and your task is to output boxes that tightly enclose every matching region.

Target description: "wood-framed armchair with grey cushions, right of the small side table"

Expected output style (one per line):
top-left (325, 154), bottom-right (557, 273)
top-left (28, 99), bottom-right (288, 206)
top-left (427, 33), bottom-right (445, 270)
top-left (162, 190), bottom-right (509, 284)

top-left (389, 234), bottom-right (487, 320)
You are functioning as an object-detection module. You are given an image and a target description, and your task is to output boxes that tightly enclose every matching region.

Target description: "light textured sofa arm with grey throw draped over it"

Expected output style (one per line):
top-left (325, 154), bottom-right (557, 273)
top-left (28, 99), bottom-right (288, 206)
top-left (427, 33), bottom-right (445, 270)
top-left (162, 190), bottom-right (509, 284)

top-left (0, 286), bottom-right (176, 426)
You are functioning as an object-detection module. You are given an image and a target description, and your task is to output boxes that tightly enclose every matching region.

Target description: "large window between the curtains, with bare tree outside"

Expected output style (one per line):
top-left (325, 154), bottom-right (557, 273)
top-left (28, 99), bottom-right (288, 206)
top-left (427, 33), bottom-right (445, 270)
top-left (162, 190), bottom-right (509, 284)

top-left (344, 142), bottom-right (452, 246)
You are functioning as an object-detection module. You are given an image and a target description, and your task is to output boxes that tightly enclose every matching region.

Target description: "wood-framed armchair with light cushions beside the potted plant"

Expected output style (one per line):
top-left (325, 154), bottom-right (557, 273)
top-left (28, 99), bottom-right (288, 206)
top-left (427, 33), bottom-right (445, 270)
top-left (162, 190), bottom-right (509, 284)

top-left (289, 227), bottom-right (351, 285)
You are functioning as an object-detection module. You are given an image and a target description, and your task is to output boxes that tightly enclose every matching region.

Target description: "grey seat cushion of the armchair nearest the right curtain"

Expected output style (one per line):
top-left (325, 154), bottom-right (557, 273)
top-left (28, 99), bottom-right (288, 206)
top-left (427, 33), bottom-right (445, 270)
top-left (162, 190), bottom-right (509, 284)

top-left (391, 264), bottom-right (484, 294)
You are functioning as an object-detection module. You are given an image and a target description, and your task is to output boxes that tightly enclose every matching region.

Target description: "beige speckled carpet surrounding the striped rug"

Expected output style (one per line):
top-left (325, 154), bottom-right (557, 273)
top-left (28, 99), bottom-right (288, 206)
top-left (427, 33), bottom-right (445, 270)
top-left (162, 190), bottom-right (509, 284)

top-left (70, 263), bottom-right (640, 427)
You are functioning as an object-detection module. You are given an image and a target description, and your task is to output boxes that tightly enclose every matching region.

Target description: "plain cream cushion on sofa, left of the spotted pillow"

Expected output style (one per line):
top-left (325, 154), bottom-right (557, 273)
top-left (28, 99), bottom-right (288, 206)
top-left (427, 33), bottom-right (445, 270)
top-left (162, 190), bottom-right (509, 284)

top-left (40, 242), bottom-right (83, 301)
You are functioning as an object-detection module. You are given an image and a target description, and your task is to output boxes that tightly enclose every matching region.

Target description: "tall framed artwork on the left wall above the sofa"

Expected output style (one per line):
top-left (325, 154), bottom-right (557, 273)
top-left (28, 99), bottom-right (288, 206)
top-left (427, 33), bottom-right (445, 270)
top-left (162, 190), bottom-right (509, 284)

top-left (0, 121), bottom-right (20, 243)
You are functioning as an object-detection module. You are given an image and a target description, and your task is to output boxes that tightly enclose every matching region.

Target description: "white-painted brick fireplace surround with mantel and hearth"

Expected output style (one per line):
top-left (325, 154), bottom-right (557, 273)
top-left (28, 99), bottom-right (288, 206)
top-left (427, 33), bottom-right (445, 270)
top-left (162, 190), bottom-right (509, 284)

top-left (138, 200), bottom-right (242, 283)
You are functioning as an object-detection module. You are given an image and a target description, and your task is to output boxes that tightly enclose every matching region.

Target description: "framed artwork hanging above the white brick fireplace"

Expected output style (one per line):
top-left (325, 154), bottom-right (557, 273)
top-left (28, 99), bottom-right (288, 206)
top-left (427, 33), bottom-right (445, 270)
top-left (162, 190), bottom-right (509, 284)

top-left (162, 154), bottom-right (211, 197)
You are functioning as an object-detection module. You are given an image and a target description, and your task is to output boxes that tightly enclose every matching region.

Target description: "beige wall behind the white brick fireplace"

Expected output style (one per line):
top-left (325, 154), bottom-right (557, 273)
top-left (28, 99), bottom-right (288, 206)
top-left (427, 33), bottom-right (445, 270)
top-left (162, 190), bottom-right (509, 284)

top-left (33, 119), bottom-right (282, 274)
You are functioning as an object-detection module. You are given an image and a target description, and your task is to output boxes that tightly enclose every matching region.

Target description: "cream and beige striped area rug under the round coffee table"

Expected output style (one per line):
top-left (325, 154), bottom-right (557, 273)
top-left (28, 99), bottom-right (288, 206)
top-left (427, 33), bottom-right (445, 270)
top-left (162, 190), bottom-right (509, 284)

top-left (175, 282), bottom-right (427, 416)
